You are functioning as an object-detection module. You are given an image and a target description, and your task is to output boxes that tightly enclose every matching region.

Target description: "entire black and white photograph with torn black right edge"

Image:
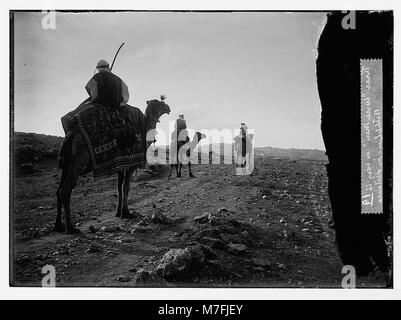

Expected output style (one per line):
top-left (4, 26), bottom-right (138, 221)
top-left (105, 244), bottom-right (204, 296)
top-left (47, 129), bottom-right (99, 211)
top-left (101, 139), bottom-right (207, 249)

top-left (7, 6), bottom-right (394, 298)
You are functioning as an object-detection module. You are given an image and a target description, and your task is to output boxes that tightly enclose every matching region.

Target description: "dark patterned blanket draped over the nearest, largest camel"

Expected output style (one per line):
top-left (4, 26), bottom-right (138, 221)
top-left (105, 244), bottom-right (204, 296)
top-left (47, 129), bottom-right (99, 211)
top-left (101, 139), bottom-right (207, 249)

top-left (61, 104), bottom-right (146, 176)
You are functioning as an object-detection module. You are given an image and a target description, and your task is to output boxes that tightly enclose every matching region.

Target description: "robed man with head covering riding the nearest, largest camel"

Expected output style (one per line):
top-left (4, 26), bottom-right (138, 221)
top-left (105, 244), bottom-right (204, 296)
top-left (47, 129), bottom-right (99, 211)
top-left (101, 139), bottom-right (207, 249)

top-left (59, 59), bottom-right (129, 165)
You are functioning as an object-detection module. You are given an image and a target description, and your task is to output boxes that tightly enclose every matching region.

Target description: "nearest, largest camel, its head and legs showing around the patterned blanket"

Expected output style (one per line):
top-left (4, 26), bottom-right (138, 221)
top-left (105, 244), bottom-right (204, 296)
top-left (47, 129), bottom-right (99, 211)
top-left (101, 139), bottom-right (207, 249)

top-left (54, 99), bottom-right (170, 234)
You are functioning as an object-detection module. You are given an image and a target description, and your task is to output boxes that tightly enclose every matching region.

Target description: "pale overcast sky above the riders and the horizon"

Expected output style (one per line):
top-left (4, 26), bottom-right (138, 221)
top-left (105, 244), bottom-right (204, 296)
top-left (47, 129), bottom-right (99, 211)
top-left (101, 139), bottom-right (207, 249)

top-left (14, 12), bottom-right (325, 149)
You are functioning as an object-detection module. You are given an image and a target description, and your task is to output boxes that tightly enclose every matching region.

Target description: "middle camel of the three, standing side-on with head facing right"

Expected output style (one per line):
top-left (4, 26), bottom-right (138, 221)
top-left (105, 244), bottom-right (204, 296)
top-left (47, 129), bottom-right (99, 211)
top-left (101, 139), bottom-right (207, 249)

top-left (168, 131), bottom-right (206, 178)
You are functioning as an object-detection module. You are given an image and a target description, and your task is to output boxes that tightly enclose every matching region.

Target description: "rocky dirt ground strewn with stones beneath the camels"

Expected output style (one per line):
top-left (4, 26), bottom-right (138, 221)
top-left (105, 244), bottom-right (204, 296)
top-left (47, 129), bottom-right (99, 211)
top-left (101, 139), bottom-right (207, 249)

top-left (10, 157), bottom-right (382, 287)
